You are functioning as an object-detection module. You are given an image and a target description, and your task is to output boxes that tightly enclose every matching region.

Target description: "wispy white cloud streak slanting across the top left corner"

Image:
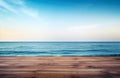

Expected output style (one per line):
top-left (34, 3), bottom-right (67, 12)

top-left (0, 0), bottom-right (39, 19)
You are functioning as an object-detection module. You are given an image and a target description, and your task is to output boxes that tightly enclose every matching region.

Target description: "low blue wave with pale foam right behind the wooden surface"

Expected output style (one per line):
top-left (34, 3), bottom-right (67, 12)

top-left (0, 50), bottom-right (120, 56)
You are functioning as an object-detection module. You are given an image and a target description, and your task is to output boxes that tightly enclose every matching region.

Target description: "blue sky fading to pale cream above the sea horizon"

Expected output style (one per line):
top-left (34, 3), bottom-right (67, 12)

top-left (0, 0), bottom-right (120, 41)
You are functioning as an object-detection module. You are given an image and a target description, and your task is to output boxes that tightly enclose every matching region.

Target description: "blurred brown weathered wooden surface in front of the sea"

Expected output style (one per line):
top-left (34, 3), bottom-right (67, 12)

top-left (0, 56), bottom-right (120, 78)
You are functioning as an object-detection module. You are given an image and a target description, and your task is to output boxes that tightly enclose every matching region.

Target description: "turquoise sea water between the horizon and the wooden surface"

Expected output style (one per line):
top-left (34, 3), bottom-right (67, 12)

top-left (0, 42), bottom-right (120, 56)
